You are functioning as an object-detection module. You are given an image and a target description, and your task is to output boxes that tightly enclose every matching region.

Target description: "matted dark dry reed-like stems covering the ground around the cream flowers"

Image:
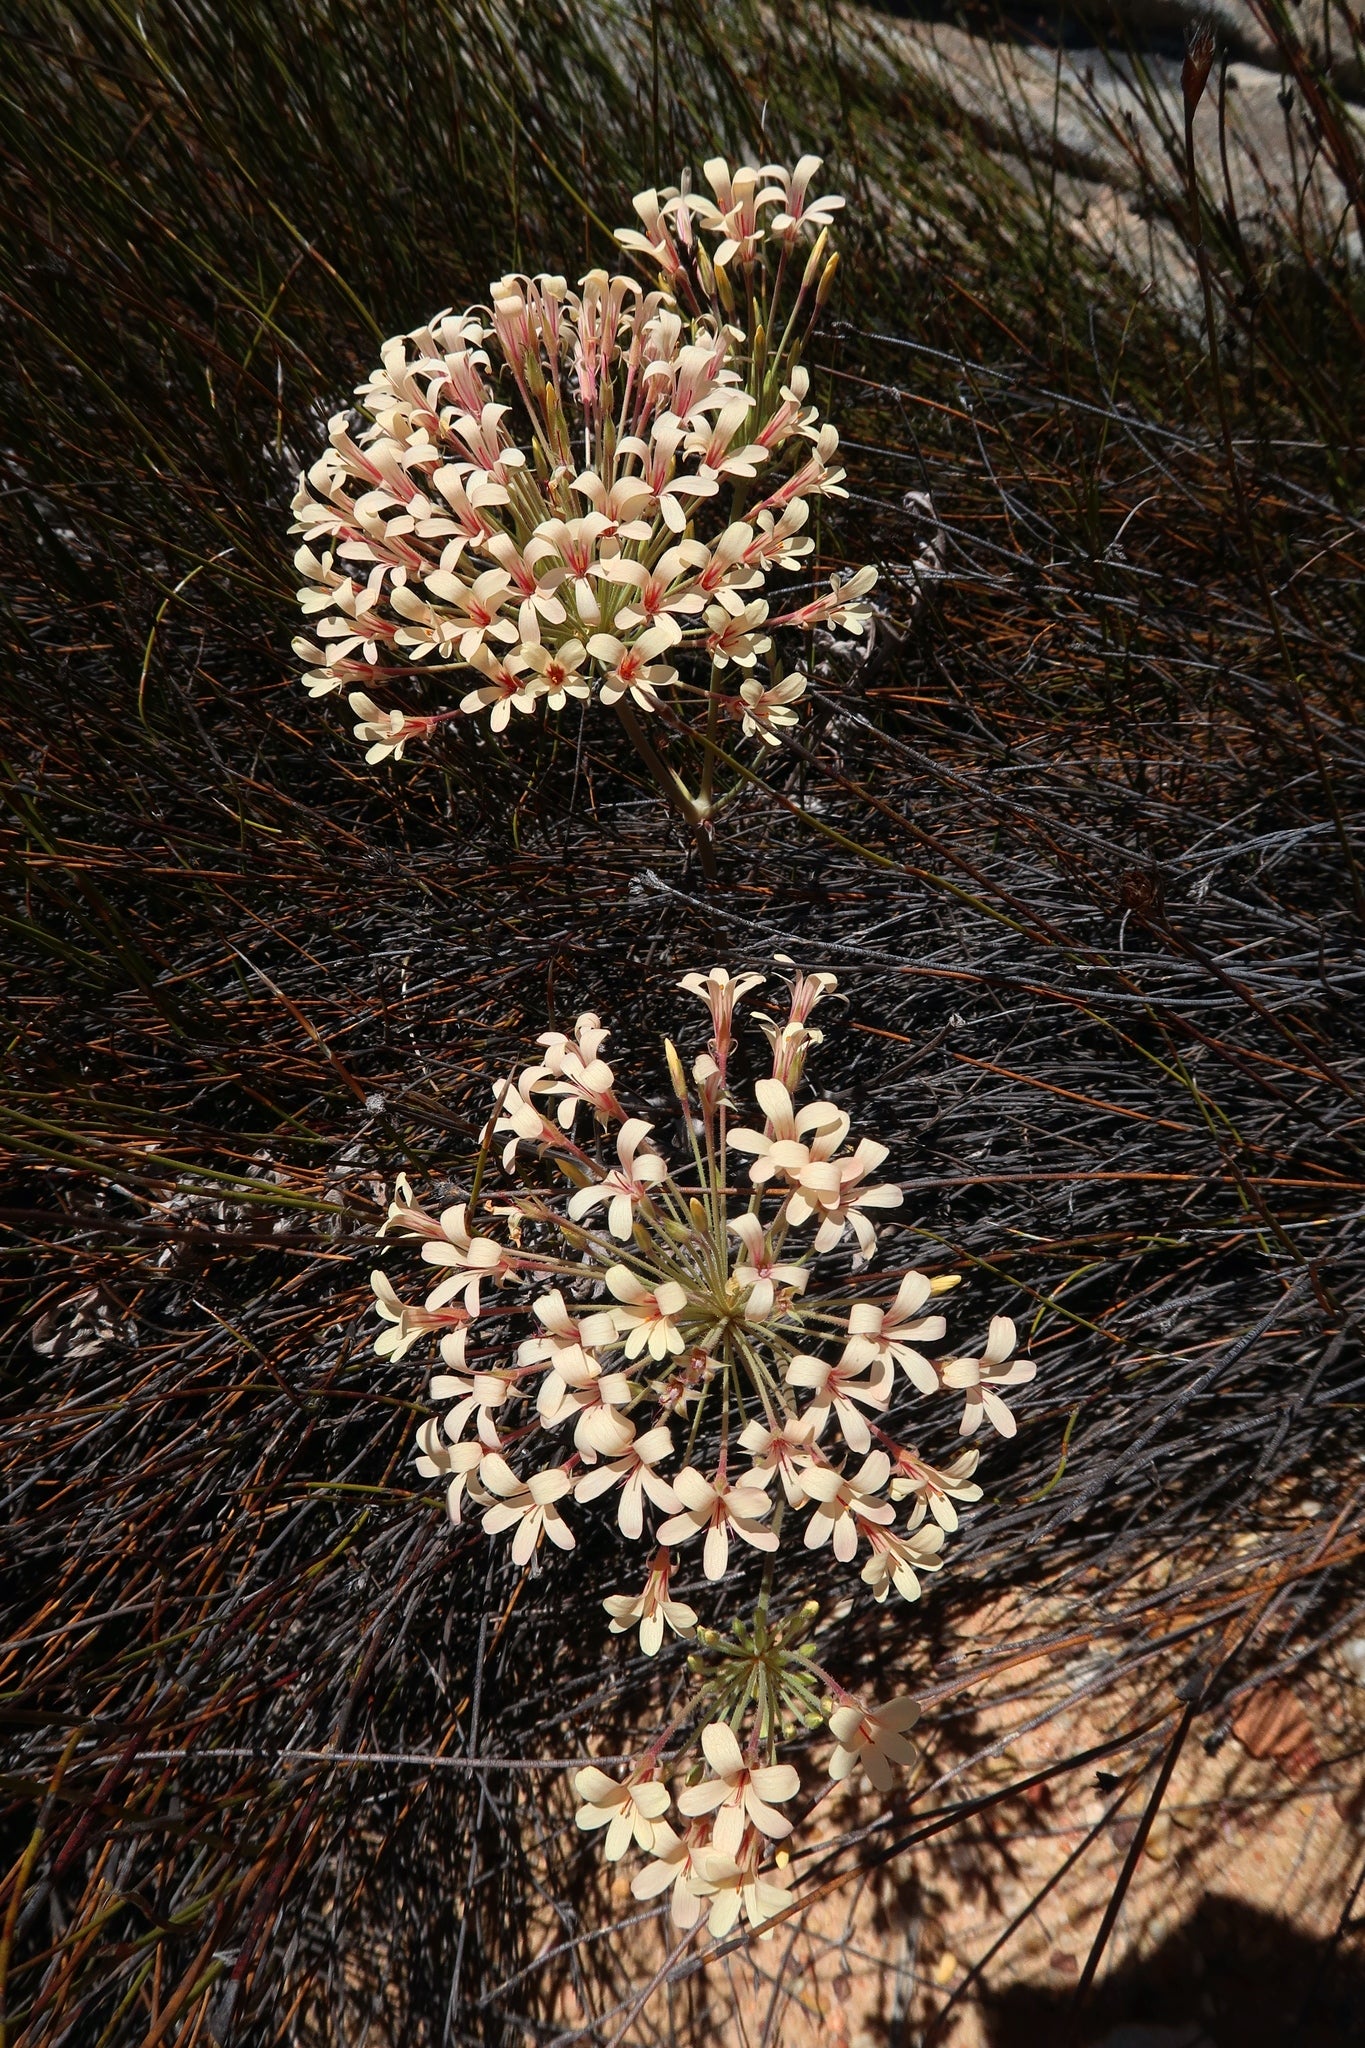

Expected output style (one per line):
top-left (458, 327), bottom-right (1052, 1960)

top-left (0, 0), bottom-right (1365, 2048)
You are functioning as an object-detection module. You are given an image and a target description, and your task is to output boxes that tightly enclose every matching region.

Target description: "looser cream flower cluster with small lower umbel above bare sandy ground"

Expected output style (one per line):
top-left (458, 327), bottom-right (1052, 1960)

top-left (372, 963), bottom-right (1036, 1935)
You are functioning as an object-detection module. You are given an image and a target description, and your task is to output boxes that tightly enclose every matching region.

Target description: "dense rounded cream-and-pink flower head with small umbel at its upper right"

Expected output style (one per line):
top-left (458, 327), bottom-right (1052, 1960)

top-left (293, 156), bottom-right (876, 864)
